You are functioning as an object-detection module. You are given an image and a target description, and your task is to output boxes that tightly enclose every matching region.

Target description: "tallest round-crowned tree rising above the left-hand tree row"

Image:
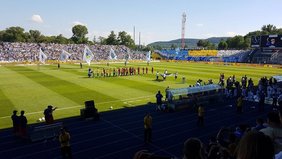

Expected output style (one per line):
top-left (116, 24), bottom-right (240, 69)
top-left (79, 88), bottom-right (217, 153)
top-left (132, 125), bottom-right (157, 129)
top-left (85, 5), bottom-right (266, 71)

top-left (71, 25), bottom-right (88, 44)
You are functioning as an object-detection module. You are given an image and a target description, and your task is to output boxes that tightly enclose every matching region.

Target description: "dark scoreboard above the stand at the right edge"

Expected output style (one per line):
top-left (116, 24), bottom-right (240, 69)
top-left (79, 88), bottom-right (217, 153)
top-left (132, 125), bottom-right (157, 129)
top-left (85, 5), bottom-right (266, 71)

top-left (251, 35), bottom-right (282, 49)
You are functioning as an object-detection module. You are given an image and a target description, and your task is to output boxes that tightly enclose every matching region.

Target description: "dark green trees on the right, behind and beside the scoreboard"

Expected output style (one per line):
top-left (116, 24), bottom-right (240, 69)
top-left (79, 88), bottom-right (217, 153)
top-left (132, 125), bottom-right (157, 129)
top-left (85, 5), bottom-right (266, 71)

top-left (197, 24), bottom-right (282, 50)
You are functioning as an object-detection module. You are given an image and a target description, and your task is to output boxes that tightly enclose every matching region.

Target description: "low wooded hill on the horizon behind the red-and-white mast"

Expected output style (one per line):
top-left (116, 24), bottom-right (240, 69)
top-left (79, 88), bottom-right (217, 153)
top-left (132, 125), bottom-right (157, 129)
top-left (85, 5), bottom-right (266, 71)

top-left (148, 37), bottom-right (229, 49)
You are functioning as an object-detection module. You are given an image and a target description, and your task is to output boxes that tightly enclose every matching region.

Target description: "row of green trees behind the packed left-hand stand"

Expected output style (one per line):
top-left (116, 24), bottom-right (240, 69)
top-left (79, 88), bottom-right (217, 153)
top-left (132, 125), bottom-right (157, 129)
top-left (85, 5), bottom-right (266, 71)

top-left (0, 25), bottom-right (150, 51)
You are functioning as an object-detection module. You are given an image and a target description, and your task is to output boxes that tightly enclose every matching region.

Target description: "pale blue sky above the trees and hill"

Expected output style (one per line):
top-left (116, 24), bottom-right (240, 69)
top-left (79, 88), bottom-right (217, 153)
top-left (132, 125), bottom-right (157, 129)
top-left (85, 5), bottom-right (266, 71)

top-left (0, 0), bottom-right (282, 44)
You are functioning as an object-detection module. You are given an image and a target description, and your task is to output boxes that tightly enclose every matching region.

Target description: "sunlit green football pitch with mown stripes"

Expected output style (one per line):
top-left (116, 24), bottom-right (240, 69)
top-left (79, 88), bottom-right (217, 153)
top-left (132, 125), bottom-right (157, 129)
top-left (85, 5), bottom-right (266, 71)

top-left (0, 62), bottom-right (282, 129)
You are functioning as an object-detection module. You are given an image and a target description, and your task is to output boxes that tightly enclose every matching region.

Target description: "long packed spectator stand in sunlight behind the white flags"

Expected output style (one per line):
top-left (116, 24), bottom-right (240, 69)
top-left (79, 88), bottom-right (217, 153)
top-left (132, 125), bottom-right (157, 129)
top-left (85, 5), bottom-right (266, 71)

top-left (0, 42), bottom-right (146, 62)
